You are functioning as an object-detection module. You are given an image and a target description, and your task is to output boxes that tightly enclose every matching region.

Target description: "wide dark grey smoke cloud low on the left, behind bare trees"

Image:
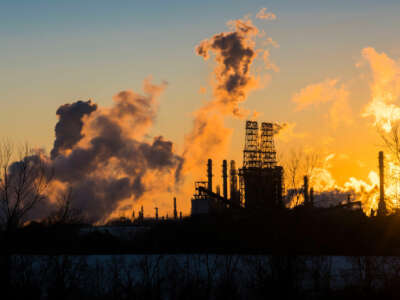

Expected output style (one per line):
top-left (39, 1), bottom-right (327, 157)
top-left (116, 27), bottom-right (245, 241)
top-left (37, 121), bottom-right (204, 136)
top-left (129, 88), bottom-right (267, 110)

top-left (22, 80), bottom-right (183, 222)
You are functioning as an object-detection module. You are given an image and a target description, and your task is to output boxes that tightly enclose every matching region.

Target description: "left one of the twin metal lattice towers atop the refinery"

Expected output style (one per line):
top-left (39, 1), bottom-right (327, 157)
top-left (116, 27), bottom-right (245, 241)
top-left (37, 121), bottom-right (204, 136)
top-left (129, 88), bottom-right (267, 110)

top-left (243, 121), bottom-right (261, 168)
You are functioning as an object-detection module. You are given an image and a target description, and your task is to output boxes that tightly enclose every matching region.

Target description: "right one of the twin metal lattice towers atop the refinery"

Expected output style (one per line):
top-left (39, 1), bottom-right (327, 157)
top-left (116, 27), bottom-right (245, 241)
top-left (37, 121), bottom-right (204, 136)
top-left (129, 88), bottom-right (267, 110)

top-left (260, 123), bottom-right (276, 168)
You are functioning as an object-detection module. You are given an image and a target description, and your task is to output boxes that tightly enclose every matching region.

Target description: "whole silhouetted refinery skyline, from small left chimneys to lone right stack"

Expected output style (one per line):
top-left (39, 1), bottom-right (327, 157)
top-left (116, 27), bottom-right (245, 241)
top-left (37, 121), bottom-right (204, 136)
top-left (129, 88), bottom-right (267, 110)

top-left (132, 120), bottom-right (390, 223)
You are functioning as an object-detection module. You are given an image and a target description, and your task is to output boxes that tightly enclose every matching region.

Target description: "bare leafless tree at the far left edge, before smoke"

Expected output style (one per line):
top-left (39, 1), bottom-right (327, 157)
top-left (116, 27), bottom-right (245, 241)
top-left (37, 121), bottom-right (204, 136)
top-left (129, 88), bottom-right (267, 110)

top-left (0, 141), bottom-right (52, 232)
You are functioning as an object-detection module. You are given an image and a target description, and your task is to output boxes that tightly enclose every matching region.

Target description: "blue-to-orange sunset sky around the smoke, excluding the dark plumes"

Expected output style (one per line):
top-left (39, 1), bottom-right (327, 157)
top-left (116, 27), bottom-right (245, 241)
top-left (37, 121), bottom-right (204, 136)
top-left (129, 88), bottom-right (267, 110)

top-left (0, 0), bottom-right (400, 218)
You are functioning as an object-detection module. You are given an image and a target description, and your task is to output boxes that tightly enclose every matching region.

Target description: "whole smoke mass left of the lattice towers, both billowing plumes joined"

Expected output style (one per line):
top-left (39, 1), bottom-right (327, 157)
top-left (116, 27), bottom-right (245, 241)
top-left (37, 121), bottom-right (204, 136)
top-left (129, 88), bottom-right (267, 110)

top-left (5, 12), bottom-right (278, 222)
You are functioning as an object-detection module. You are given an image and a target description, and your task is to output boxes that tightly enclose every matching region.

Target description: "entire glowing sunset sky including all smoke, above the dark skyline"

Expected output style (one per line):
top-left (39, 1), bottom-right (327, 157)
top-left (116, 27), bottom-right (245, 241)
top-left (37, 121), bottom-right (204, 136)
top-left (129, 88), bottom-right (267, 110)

top-left (0, 1), bottom-right (400, 223)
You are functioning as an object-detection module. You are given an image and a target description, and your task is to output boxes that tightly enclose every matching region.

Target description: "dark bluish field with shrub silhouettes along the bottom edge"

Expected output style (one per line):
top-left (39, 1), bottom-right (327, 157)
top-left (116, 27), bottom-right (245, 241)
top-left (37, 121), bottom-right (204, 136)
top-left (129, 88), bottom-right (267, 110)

top-left (2, 254), bottom-right (400, 300)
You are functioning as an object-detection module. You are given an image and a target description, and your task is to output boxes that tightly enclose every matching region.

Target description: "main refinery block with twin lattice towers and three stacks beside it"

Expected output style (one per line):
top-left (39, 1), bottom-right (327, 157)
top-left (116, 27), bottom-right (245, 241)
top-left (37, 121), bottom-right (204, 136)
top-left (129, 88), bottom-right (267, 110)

top-left (192, 121), bottom-right (284, 215)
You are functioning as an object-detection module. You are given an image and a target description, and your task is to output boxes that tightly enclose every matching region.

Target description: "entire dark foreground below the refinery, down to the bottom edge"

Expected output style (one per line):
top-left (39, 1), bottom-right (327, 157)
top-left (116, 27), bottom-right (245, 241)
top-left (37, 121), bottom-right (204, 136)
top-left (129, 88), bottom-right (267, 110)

top-left (0, 207), bottom-right (400, 299)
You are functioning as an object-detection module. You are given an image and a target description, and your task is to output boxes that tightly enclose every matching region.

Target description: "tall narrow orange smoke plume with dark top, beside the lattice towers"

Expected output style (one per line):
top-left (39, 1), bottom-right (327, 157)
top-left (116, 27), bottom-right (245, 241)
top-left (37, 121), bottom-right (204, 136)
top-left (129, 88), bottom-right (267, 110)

top-left (184, 19), bottom-right (272, 170)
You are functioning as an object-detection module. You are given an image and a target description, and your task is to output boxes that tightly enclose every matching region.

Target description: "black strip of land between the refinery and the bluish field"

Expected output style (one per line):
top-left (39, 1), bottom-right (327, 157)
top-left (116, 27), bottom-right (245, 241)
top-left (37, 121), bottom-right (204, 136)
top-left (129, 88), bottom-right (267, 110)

top-left (1, 207), bottom-right (400, 255)
